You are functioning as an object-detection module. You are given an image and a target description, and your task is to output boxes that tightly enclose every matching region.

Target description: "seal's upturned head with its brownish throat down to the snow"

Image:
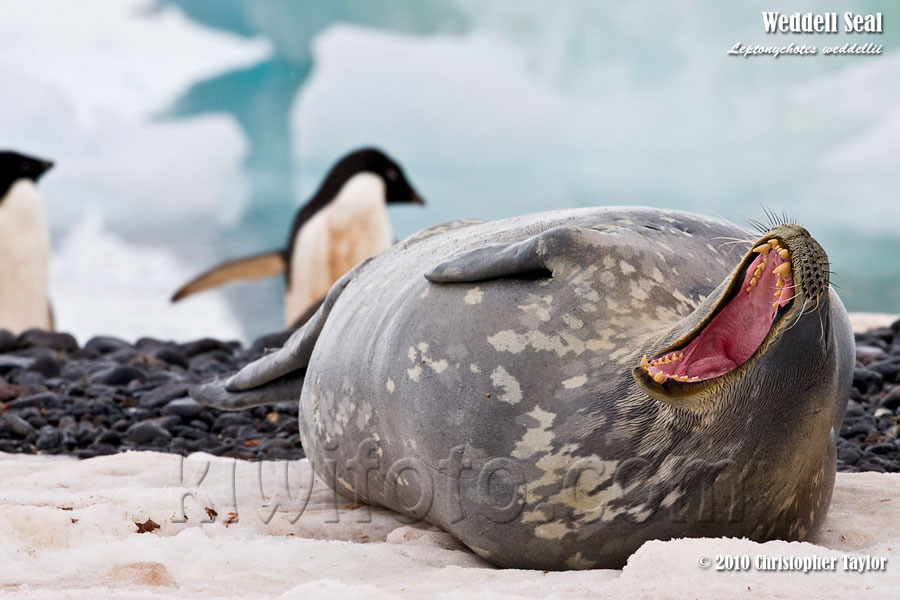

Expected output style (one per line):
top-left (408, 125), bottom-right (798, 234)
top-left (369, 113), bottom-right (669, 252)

top-left (633, 224), bottom-right (855, 541)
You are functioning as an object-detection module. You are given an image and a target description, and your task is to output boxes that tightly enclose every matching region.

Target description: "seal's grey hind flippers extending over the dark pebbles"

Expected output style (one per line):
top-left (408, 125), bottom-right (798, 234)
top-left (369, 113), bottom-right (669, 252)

top-left (190, 259), bottom-right (369, 410)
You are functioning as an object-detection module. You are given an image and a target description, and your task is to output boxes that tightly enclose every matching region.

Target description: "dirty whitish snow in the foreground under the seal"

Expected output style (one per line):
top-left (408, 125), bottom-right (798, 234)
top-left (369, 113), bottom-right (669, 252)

top-left (0, 452), bottom-right (900, 600)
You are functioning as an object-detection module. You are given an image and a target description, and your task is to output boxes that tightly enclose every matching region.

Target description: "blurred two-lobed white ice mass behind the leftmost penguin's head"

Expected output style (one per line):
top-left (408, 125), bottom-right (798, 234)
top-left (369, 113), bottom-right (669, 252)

top-left (0, 0), bottom-right (260, 231)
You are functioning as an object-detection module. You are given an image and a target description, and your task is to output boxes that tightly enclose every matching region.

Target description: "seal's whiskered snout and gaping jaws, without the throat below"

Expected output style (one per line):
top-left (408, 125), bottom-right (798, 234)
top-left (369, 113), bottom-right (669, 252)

top-left (633, 224), bottom-right (843, 409)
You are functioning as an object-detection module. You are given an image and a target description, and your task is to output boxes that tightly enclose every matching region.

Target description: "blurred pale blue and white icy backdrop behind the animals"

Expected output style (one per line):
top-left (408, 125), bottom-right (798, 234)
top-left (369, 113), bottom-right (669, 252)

top-left (0, 0), bottom-right (900, 336)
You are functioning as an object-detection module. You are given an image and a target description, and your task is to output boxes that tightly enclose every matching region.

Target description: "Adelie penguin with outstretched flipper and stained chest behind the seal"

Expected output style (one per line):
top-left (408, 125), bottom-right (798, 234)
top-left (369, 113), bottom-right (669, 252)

top-left (172, 148), bottom-right (425, 326)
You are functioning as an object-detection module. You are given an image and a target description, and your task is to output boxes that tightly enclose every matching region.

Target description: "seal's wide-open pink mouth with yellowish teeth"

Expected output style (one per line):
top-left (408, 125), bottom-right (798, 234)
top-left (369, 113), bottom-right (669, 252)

top-left (641, 238), bottom-right (795, 384)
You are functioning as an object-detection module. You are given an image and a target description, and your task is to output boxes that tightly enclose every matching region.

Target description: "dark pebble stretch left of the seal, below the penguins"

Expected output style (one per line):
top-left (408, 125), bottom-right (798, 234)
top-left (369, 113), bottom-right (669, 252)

top-left (0, 330), bottom-right (304, 460)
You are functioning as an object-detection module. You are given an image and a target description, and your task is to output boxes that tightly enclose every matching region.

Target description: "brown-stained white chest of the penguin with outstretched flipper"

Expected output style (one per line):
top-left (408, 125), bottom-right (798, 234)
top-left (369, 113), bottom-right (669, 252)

top-left (285, 173), bottom-right (394, 325)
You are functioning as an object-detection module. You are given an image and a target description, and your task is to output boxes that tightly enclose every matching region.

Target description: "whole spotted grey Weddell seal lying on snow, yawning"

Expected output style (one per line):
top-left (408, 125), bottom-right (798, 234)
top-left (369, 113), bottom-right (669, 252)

top-left (192, 207), bottom-right (854, 569)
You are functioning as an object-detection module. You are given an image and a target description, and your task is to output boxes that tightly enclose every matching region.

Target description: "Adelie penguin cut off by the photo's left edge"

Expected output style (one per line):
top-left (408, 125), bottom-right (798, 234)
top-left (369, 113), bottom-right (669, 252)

top-left (0, 151), bottom-right (53, 333)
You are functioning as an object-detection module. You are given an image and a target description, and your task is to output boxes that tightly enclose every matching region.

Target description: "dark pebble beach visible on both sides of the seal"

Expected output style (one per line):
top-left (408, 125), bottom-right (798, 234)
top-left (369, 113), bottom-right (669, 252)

top-left (0, 320), bottom-right (900, 472)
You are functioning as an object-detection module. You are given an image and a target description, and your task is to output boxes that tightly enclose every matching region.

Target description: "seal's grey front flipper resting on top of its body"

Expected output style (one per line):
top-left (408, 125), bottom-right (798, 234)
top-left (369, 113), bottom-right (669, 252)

top-left (425, 226), bottom-right (598, 283)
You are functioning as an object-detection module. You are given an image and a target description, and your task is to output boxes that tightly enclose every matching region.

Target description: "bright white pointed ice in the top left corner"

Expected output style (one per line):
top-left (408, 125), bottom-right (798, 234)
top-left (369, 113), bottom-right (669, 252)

top-left (0, 0), bottom-right (271, 127)
